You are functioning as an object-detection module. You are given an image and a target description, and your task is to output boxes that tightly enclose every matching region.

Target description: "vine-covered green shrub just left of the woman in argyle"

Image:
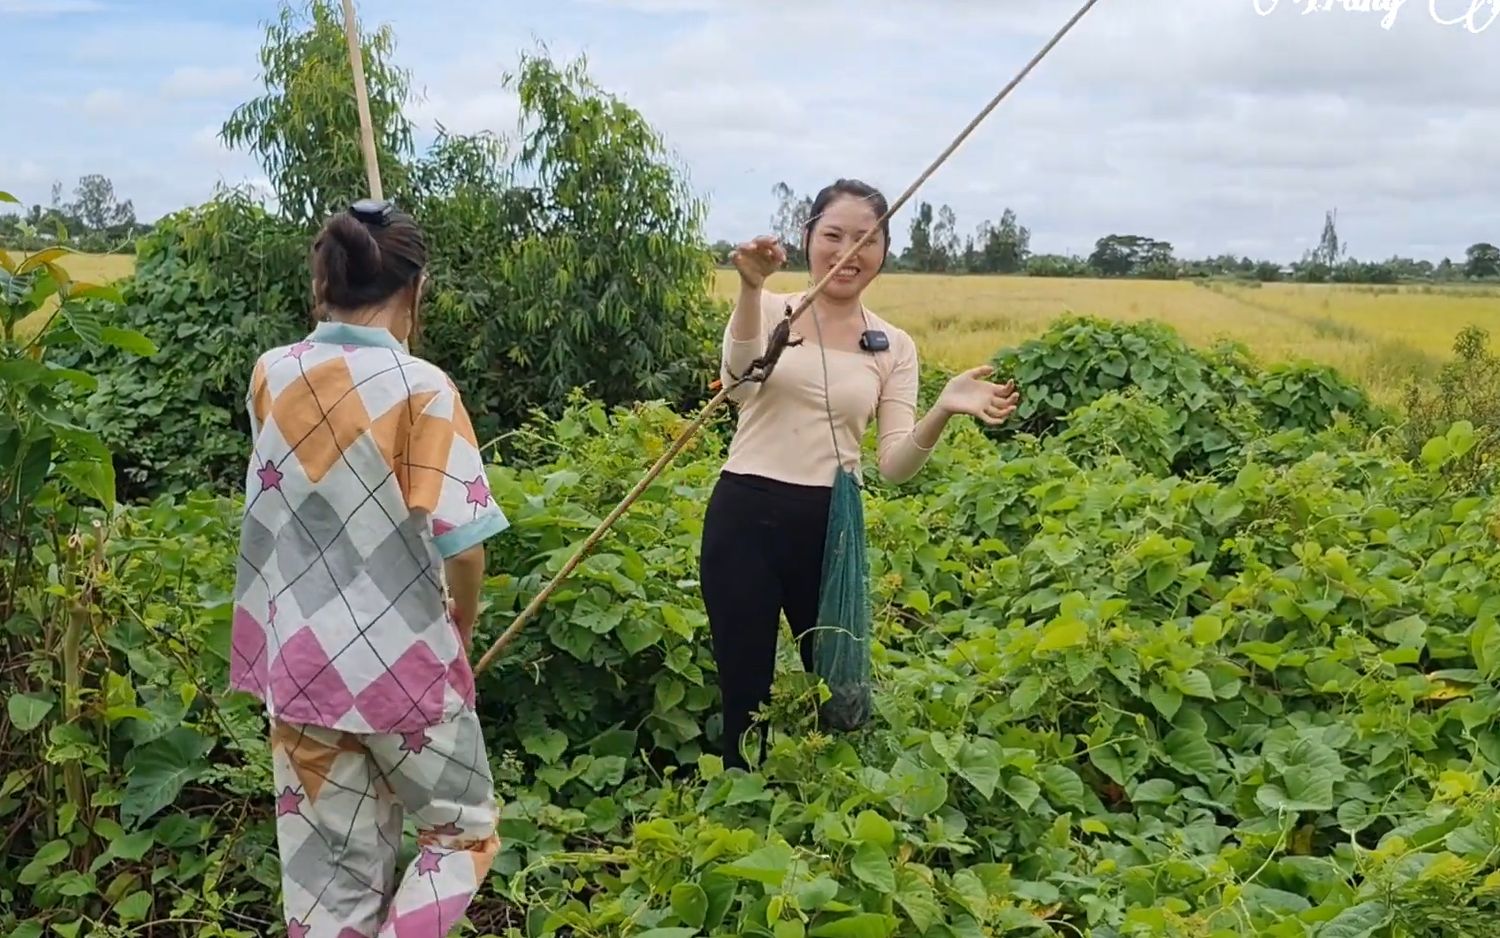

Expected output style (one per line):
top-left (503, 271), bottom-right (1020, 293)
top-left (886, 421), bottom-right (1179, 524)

top-left (54, 191), bottom-right (312, 498)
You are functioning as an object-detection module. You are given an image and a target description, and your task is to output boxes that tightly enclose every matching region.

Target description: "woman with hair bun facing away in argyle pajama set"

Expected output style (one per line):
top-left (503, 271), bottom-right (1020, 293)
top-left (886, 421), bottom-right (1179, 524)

top-left (230, 201), bottom-right (507, 938)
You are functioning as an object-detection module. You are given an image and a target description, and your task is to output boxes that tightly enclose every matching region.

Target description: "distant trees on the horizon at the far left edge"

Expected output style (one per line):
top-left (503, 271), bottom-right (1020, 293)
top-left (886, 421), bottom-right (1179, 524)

top-left (0, 173), bottom-right (152, 252)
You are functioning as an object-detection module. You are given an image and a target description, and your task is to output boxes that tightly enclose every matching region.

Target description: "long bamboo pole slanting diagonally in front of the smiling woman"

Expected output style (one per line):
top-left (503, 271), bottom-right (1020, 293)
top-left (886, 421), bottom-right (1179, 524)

top-left (474, 0), bottom-right (1098, 674)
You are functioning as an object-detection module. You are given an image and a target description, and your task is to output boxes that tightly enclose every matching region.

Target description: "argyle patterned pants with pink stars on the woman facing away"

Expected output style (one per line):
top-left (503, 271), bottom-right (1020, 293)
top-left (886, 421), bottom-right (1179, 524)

top-left (272, 710), bottom-right (500, 938)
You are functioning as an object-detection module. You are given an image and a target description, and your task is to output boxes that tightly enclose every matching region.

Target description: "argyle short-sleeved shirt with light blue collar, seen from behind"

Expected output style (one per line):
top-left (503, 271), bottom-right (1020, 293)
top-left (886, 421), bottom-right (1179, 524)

top-left (230, 323), bottom-right (509, 732)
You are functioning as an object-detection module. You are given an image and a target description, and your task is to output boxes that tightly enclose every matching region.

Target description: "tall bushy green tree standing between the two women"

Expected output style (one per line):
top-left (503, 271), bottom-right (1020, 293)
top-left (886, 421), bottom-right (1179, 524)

top-left (417, 54), bottom-right (723, 434)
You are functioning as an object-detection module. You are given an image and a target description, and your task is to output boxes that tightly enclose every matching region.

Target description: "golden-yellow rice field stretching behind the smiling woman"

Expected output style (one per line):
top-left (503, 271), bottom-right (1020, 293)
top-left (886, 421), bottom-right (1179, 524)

top-left (717, 270), bottom-right (1500, 402)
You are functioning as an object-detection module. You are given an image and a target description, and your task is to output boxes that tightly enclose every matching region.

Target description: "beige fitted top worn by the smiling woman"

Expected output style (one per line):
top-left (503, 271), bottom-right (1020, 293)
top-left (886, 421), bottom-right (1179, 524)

top-left (720, 291), bottom-right (932, 485)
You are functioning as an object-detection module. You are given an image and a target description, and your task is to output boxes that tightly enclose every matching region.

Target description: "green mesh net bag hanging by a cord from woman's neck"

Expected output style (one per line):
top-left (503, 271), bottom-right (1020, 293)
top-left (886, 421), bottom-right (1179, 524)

top-left (813, 312), bottom-right (873, 729)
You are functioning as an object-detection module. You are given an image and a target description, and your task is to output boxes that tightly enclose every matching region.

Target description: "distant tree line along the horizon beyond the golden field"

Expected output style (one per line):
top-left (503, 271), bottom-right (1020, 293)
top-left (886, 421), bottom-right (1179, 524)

top-left (713, 182), bottom-right (1500, 284)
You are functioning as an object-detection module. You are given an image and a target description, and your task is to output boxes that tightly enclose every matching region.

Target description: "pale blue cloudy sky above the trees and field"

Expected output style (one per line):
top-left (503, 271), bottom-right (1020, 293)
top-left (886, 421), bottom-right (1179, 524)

top-left (0, 0), bottom-right (1500, 260)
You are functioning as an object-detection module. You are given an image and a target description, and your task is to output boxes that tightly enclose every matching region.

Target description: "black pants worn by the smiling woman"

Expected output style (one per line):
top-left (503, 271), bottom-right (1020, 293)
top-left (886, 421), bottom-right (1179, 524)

top-left (699, 473), bottom-right (833, 768)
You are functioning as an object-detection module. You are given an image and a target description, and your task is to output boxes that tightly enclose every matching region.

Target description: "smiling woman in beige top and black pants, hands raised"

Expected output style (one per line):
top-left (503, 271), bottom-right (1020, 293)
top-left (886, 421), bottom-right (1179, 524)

top-left (699, 180), bottom-right (1017, 768)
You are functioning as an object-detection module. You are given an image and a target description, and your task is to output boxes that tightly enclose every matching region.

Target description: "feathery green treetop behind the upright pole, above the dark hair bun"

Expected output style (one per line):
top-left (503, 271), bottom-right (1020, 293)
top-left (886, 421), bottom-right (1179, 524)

top-left (219, 0), bottom-right (413, 227)
